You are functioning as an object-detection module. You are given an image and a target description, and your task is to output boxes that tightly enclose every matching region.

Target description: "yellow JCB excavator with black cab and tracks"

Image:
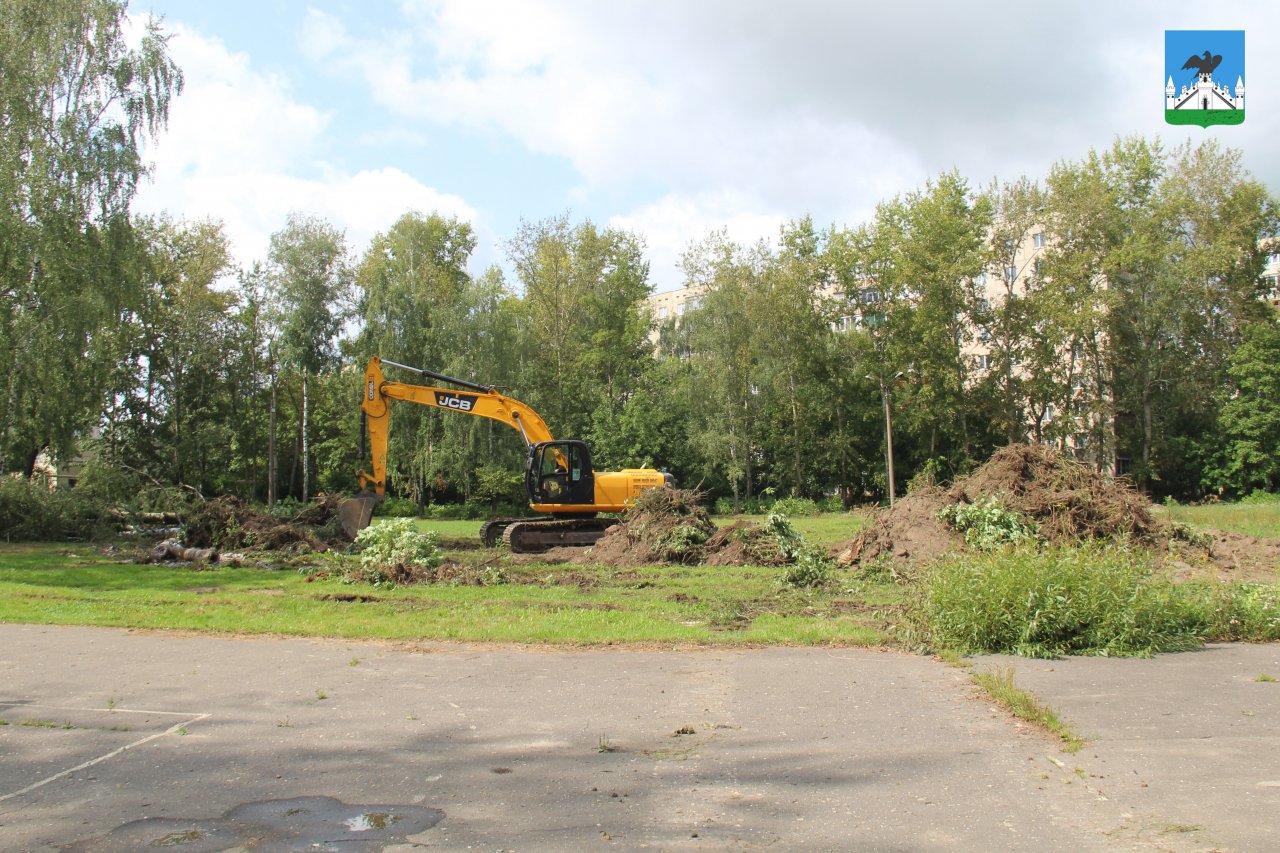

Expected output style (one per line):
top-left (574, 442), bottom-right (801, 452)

top-left (338, 356), bottom-right (675, 553)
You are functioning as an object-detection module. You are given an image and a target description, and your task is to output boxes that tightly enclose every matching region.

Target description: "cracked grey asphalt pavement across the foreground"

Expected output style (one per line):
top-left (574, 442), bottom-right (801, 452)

top-left (0, 625), bottom-right (1280, 853)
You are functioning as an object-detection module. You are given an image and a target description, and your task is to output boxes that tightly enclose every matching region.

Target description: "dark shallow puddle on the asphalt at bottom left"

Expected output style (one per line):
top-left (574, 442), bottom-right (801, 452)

top-left (63, 797), bottom-right (444, 853)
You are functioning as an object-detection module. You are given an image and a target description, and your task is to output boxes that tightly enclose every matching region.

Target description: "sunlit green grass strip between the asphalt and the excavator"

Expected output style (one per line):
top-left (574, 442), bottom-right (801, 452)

top-left (0, 537), bottom-right (901, 646)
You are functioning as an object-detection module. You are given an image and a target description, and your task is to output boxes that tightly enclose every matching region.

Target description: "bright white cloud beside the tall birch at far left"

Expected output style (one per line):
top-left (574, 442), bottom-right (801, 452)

top-left (136, 24), bottom-right (476, 264)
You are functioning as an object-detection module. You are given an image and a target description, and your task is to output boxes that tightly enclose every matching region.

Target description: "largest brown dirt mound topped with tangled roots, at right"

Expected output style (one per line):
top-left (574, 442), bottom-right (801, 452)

top-left (838, 444), bottom-right (1167, 565)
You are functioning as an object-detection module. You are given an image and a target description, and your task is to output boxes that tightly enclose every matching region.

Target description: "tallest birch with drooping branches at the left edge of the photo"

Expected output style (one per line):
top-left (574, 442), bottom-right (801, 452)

top-left (0, 0), bottom-right (182, 474)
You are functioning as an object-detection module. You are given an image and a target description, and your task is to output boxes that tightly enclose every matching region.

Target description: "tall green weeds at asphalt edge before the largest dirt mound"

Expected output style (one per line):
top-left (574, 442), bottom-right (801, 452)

top-left (915, 546), bottom-right (1218, 657)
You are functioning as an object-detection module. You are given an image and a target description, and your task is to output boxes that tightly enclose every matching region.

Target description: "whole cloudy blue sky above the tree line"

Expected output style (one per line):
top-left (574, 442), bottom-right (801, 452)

top-left (131, 0), bottom-right (1280, 289)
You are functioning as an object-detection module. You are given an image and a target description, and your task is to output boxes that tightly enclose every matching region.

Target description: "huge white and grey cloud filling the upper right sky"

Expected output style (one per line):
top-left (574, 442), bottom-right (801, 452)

top-left (314, 0), bottom-right (1277, 202)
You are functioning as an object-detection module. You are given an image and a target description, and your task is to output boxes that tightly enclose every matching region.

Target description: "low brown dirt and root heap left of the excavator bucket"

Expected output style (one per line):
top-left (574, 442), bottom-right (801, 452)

top-left (183, 494), bottom-right (343, 551)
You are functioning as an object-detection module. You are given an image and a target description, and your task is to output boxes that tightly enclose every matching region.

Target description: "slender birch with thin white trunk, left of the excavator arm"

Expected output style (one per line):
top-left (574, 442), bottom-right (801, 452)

top-left (268, 213), bottom-right (352, 501)
